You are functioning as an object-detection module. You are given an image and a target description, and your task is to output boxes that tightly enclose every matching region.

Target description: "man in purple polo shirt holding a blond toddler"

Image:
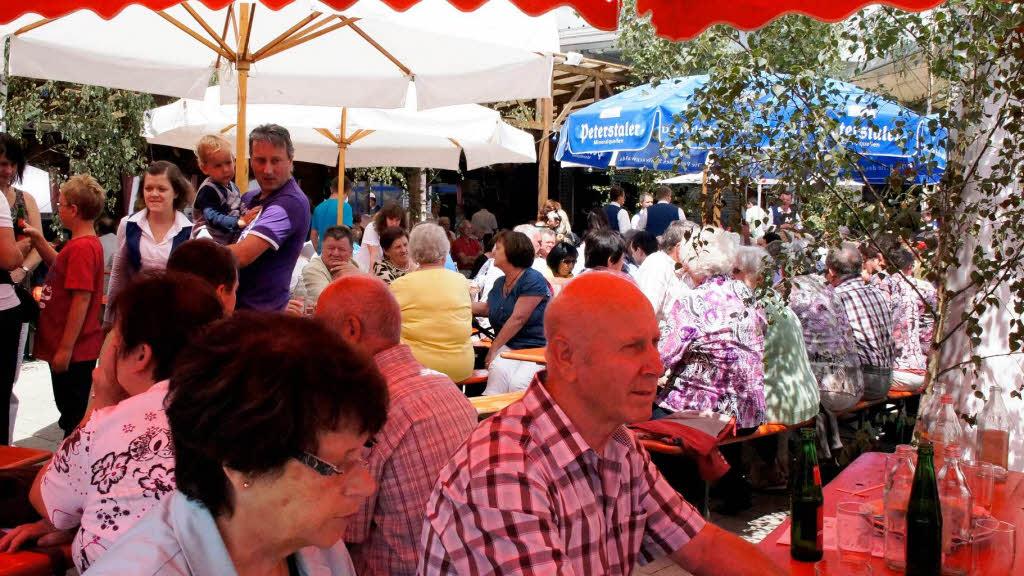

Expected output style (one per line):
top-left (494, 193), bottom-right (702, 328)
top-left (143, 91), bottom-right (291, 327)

top-left (229, 124), bottom-right (310, 311)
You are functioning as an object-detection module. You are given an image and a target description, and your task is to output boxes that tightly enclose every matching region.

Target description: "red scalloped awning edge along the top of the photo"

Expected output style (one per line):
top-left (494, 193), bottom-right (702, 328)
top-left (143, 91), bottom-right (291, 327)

top-left (0, 0), bottom-right (943, 40)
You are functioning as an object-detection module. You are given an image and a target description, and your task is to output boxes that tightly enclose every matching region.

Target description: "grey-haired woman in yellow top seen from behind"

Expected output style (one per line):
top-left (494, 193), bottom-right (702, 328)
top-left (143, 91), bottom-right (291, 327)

top-left (389, 223), bottom-right (473, 382)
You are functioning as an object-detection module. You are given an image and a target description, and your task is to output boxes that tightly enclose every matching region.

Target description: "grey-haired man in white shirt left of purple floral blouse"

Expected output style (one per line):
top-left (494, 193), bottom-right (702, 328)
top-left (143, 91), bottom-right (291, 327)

top-left (636, 220), bottom-right (697, 336)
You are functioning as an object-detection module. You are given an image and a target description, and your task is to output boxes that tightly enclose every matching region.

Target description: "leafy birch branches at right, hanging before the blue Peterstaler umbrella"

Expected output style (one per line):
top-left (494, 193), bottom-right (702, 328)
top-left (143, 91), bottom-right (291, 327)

top-left (620, 0), bottom-right (1024, 389)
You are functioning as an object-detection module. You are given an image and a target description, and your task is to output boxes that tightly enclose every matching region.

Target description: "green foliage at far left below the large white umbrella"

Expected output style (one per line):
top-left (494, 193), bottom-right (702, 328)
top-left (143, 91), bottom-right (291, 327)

top-left (4, 77), bottom-right (155, 199)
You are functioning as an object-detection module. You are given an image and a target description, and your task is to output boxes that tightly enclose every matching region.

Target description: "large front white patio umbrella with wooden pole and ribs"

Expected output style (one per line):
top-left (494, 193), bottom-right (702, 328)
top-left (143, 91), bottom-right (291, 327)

top-left (0, 0), bottom-right (559, 180)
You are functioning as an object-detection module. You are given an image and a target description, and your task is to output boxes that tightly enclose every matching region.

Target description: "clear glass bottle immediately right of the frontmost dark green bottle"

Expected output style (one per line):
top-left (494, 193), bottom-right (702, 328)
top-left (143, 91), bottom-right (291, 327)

top-left (936, 445), bottom-right (974, 576)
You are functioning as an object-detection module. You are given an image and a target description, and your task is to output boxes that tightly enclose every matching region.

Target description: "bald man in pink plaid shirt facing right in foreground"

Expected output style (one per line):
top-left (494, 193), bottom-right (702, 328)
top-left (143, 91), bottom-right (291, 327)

top-left (417, 272), bottom-right (784, 576)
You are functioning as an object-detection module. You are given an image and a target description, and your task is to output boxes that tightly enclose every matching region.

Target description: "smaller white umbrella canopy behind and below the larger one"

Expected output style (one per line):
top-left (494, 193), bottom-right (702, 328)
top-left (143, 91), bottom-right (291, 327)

top-left (143, 86), bottom-right (537, 170)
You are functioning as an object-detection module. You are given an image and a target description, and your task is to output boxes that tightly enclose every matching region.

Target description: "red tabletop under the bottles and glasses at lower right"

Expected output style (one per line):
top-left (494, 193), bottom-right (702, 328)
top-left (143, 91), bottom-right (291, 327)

top-left (758, 452), bottom-right (1024, 576)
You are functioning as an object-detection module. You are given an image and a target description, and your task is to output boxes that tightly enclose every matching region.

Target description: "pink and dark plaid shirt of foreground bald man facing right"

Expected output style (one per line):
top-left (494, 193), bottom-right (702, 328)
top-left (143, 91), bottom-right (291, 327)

top-left (418, 372), bottom-right (705, 576)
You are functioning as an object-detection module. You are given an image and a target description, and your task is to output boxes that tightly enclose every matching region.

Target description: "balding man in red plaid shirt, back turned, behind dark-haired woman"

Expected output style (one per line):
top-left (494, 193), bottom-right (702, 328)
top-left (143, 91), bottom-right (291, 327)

top-left (316, 275), bottom-right (476, 576)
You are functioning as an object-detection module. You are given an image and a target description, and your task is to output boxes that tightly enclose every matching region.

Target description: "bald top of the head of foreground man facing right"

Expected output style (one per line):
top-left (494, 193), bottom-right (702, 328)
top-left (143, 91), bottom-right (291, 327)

top-left (544, 272), bottom-right (656, 350)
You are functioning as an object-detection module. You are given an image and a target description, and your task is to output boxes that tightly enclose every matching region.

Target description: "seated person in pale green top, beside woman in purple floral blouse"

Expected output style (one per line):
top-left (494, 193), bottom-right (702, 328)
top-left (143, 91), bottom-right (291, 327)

top-left (732, 246), bottom-right (819, 426)
